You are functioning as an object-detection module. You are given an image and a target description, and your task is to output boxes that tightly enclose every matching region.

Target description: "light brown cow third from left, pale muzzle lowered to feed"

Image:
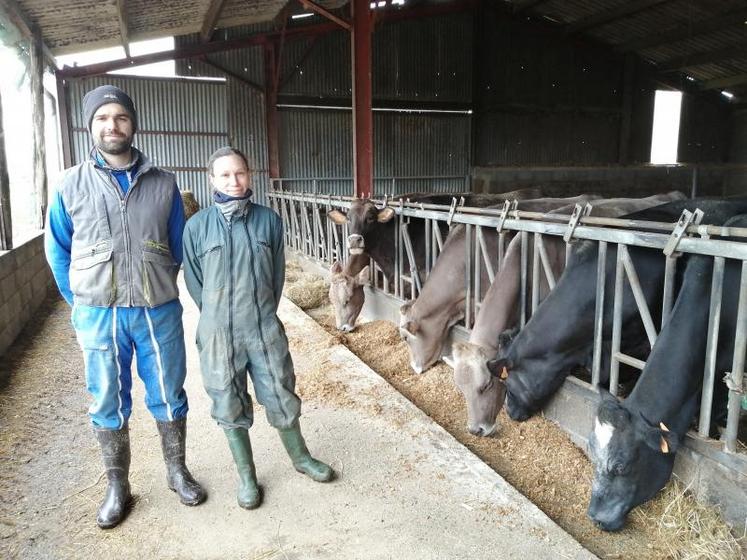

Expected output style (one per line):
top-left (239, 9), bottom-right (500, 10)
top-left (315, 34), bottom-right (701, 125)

top-left (400, 195), bottom-right (599, 373)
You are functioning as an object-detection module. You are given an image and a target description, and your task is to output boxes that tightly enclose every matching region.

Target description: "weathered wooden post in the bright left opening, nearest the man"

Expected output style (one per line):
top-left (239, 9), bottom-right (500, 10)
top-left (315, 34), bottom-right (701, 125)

top-left (29, 30), bottom-right (47, 229)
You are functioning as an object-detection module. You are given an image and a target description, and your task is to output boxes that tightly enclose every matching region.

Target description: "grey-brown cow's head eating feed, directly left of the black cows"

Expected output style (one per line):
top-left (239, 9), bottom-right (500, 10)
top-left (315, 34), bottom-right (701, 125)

top-left (452, 342), bottom-right (506, 436)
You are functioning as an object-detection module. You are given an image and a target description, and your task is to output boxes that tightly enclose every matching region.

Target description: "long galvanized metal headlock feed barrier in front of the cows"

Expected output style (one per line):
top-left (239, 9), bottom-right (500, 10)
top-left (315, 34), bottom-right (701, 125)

top-left (268, 191), bottom-right (747, 458)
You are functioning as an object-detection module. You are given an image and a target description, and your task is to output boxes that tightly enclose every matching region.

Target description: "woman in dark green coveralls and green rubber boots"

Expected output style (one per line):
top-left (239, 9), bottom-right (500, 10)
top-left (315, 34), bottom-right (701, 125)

top-left (184, 148), bottom-right (334, 509)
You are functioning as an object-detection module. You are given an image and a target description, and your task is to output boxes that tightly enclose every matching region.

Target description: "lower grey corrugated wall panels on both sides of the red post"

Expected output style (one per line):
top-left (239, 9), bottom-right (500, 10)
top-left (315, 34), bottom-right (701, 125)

top-left (279, 109), bottom-right (470, 194)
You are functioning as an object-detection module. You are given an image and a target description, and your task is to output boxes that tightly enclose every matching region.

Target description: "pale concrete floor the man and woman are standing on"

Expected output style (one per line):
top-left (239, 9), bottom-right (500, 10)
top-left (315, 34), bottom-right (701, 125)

top-left (0, 278), bottom-right (594, 560)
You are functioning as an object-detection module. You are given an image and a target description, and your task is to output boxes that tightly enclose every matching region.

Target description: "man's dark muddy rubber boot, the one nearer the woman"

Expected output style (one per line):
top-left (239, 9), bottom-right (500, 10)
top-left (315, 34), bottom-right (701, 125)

top-left (156, 417), bottom-right (207, 506)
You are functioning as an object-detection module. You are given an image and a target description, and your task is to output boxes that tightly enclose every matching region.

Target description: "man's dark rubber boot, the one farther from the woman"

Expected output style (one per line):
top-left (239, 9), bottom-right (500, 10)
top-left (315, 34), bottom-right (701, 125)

top-left (93, 426), bottom-right (132, 529)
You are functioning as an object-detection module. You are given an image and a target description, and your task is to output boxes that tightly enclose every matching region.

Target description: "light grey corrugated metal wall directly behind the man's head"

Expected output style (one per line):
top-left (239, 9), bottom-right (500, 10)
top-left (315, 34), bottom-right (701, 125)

top-left (69, 76), bottom-right (228, 207)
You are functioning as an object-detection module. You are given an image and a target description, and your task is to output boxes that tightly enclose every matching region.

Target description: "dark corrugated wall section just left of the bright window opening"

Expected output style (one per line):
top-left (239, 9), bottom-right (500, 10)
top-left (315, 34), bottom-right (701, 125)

top-left (474, 10), bottom-right (623, 166)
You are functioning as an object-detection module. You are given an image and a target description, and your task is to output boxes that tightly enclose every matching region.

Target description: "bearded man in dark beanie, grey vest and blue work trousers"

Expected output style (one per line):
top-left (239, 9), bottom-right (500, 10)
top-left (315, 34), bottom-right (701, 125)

top-left (45, 85), bottom-right (206, 529)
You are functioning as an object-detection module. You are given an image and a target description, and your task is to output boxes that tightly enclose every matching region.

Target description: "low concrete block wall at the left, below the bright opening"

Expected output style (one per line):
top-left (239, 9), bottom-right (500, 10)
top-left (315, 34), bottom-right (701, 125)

top-left (0, 233), bottom-right (54, 356)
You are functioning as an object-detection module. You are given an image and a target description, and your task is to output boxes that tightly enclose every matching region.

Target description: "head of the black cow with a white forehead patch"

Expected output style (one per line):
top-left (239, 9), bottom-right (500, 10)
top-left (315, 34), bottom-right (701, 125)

top-left (587, 389), bottom-right (679, 531)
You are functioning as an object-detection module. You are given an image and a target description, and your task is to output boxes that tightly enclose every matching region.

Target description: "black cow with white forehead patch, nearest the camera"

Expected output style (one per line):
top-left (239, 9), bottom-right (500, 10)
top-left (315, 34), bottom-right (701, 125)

top-left (587, 215), bottom-right (747, 531)
